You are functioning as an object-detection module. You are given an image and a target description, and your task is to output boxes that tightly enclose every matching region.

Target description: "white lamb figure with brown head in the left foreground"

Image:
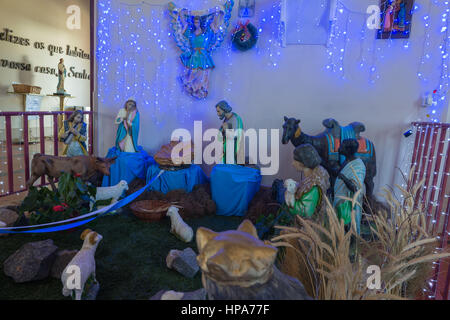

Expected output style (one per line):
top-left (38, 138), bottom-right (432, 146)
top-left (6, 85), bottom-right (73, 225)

top-left (61, 229), bottom-right (103, 300)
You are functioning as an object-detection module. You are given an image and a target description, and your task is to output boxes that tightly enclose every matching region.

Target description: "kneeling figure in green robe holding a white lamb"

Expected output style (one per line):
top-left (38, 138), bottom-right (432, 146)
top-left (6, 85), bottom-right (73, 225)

top-left (285, 144), bottom-right (330, 222)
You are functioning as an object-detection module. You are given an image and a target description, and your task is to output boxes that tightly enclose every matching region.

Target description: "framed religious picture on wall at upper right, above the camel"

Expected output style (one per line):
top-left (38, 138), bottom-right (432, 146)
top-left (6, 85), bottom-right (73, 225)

top-left (377, 0), bottom-right (414, 39)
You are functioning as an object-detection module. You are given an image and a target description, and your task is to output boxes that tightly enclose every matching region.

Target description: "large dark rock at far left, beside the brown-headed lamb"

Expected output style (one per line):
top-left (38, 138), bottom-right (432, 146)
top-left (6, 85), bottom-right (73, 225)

top-left (3, 239), bottom-right (58, 283)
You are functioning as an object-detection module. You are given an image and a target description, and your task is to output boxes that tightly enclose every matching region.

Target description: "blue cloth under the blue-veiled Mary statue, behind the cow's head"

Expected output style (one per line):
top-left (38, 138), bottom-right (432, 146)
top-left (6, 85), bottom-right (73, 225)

top-left (102, 147), bottom-right (159, 187)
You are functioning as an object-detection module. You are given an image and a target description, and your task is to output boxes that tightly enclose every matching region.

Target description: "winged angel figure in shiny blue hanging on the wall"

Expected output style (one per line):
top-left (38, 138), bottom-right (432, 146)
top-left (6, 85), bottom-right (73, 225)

top-left (169, 0), bottom-right (234, 99)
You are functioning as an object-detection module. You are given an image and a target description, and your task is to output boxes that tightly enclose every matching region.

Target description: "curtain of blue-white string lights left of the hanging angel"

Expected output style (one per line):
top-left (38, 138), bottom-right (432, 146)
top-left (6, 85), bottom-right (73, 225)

top-left (96, 0), bottom-right (196, 132)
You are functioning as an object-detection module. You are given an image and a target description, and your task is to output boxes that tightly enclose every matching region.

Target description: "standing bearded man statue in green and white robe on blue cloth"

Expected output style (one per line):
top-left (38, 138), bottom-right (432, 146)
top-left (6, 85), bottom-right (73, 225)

top-left (216, 101), bottom-right (245, 164)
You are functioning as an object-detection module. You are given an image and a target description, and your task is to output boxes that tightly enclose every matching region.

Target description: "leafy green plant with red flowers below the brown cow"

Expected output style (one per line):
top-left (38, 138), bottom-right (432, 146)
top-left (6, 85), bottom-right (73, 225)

top-left (19, 173), bottom-right (97, 225)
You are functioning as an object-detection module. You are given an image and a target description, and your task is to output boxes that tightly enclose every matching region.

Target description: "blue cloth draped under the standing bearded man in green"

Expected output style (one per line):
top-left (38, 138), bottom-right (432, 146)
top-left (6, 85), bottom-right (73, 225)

top-left (211, 164), bottom-right (262, 217)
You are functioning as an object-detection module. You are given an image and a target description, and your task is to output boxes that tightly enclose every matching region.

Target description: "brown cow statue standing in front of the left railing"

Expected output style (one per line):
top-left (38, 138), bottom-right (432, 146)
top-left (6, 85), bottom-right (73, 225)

top-left (27, 153), bottom-right (117, 191)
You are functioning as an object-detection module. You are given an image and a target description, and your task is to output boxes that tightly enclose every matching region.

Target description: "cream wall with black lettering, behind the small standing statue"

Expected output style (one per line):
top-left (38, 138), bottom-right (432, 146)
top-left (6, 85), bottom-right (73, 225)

top-left (0, 0), bottom-right (90, 111)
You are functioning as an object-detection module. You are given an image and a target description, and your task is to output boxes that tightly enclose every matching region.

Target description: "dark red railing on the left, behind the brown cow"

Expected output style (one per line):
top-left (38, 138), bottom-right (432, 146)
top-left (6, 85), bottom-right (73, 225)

top-left (0, 111), bottom-right (93, 198)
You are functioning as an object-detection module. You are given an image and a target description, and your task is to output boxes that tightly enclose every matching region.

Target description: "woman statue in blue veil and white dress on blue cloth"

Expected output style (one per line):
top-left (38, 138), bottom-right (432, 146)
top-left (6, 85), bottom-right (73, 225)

top-left (116, 100), bottom-right (139, 152)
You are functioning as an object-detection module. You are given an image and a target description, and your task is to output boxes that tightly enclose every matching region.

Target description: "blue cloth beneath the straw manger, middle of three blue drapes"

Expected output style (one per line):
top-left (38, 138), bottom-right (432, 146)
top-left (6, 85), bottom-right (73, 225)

top-left (147, 164), bottom-right (208, 194)
